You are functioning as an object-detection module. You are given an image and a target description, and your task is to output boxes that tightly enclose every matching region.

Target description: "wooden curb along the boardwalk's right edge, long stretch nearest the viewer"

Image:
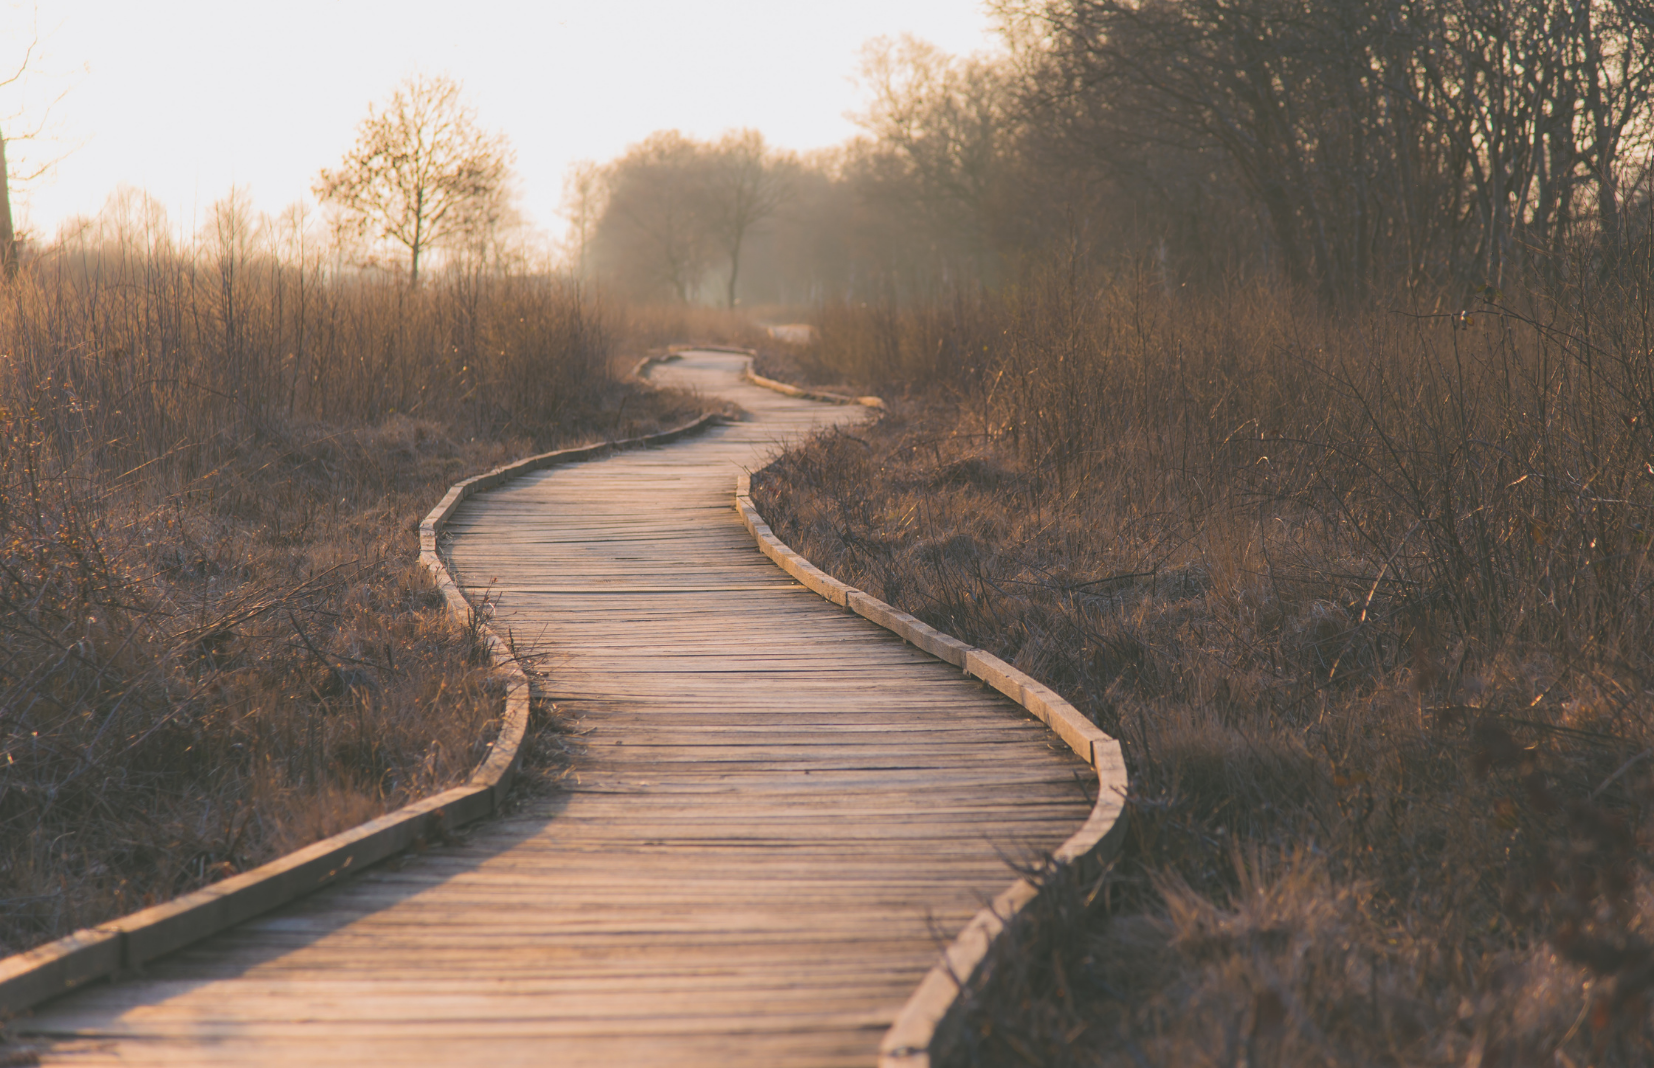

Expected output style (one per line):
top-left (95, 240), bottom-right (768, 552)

top-left (734, 472), bottom-right (1126, 1068)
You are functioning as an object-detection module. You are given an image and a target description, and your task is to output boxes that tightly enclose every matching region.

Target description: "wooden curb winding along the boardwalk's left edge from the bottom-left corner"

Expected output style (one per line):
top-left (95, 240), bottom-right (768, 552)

top-left (0, 410), bottom-right (719, 1018)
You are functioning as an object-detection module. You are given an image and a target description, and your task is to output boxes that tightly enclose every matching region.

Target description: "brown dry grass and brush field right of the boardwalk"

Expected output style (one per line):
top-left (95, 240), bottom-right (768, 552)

top-left (754, 273), bottom-right (1654, 1065)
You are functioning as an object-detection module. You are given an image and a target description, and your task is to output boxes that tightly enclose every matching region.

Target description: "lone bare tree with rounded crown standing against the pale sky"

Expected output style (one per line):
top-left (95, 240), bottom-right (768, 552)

top-left (314, 76), bottom-right (511, 286)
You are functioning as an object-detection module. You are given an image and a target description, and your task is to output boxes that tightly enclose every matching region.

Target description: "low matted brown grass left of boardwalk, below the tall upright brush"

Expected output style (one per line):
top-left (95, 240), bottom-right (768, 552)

top-left (0, 406), bottom-right (498, 949)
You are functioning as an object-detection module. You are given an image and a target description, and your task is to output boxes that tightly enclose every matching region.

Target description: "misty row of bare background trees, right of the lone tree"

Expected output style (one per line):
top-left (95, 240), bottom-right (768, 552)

top-left (579, 0), bottom-right (1654, 303)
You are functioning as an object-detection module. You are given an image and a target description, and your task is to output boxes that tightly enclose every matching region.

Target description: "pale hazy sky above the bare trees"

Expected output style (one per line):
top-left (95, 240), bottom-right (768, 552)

top-left (0, 0), bottom-right (992, 246)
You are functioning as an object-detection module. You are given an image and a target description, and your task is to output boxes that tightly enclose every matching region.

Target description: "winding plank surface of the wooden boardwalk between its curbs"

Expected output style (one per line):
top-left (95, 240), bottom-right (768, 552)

top-left (12, 354), bottom-right (1095, 1068)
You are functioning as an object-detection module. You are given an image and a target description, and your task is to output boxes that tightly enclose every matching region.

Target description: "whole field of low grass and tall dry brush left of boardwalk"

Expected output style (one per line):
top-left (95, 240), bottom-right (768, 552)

top-left (0, 233), bottom-right (700, 954)
